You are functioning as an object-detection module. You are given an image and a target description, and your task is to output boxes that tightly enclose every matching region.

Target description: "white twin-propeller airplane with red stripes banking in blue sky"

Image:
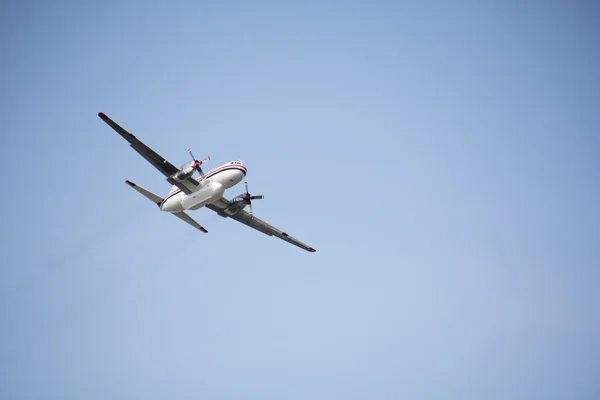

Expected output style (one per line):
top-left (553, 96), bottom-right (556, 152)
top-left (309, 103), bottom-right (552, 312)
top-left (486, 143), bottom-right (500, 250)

top-left (98, 112), bottom-right (316, 253)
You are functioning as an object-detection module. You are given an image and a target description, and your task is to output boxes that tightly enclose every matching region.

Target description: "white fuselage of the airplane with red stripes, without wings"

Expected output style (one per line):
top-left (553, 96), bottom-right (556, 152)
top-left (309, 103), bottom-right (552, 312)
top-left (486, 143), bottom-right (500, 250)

top-left (160, 161), bottom-right (247, 213)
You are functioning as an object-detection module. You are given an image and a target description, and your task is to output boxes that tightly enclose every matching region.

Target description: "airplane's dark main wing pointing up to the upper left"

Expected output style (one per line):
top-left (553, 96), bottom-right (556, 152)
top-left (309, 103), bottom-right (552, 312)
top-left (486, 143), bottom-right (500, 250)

top-left (98, 112), bottom-right (199, 194)
